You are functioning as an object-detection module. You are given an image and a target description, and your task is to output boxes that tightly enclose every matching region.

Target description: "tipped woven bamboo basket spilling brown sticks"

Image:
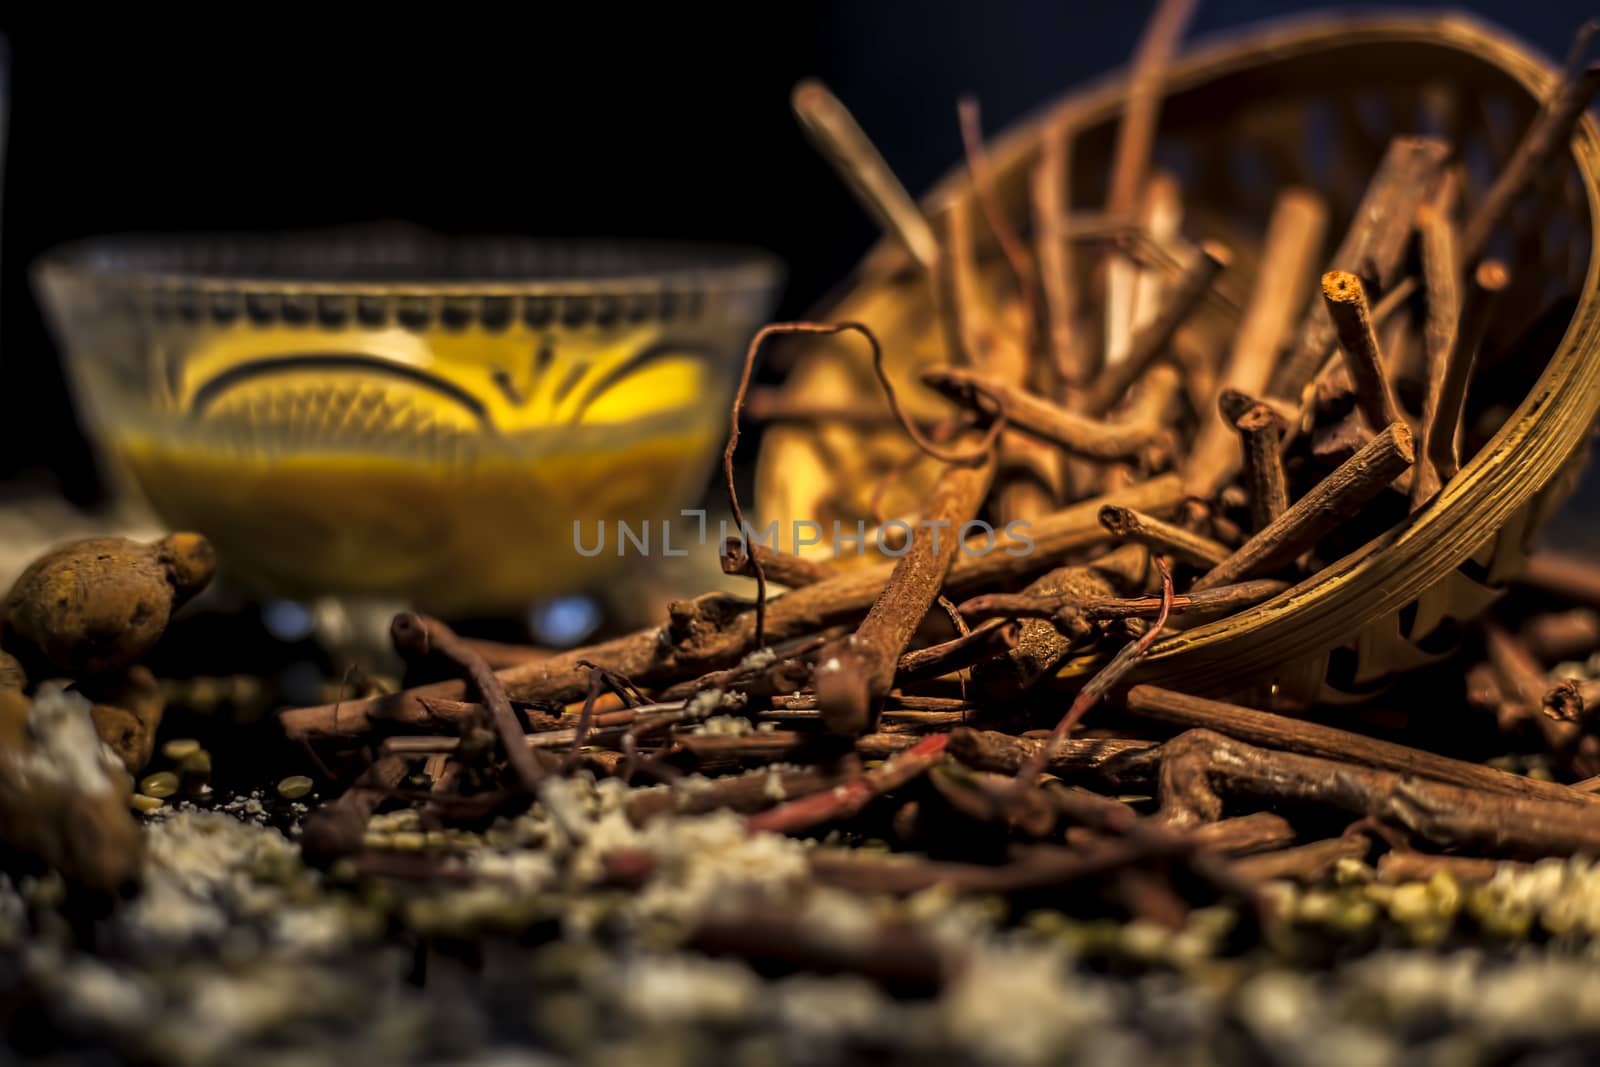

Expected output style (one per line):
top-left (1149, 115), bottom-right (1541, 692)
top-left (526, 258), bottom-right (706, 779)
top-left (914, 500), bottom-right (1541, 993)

top-left (757, 16), bottom-right (1600, 707)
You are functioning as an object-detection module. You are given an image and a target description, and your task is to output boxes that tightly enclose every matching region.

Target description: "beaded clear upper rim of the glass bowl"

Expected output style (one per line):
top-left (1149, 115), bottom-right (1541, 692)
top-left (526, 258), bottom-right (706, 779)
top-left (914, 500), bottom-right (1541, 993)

top-left (30, 224), bottom-right (784, 296)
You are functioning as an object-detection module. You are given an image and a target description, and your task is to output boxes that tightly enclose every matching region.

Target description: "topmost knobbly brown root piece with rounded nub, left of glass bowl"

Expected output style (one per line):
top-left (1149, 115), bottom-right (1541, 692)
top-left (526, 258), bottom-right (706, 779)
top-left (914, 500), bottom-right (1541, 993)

top-left (5, 533), bottom-right (216, 677)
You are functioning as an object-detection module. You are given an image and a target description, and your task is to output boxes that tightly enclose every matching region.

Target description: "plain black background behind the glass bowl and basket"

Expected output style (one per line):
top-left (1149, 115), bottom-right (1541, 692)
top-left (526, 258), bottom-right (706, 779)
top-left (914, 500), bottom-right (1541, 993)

top-left (0, 0), bottom-right (1592, 504)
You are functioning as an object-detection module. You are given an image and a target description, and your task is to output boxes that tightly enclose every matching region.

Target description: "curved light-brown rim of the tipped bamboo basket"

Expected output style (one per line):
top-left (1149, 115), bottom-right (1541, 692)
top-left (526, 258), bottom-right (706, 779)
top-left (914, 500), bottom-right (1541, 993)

top-left (812, 13), bottom-right (1600, 693)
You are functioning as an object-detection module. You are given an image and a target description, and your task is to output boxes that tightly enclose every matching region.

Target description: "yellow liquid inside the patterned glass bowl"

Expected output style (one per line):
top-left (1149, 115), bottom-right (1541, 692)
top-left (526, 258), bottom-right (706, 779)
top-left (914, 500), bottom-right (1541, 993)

top-left (106, 322), bottom-right (726, 614)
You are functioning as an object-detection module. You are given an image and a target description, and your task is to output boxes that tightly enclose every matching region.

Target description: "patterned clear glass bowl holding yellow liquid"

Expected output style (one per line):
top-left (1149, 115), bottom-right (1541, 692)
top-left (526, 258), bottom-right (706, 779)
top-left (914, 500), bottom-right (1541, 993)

top-left (35, 229), bottom-right (781, 616)
